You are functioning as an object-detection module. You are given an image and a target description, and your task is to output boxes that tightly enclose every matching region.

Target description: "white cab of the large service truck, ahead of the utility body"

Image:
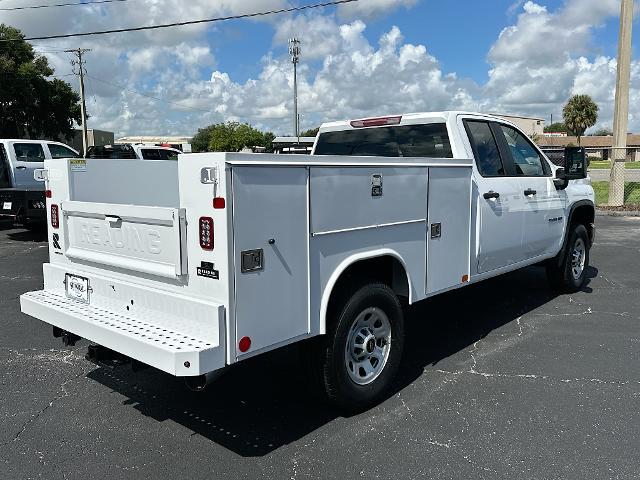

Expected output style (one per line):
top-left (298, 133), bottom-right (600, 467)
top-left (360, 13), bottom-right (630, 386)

top-left (312, 112), bottom-right (595, 280)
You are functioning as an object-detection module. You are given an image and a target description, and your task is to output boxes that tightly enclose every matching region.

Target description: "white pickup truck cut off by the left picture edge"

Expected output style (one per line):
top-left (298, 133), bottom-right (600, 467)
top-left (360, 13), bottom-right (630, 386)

top-left (0, 139), bottom-right (79, 227)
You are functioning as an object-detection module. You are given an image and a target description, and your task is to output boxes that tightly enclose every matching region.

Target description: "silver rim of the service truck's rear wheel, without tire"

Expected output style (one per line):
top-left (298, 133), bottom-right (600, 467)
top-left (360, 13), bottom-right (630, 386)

top-left (344, 307), bottom-right (391, 385)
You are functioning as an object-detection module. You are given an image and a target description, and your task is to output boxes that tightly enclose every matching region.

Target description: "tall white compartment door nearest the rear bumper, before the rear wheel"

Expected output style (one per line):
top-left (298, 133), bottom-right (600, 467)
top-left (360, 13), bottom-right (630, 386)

top-left (232, 166), bottom-right (309, 358)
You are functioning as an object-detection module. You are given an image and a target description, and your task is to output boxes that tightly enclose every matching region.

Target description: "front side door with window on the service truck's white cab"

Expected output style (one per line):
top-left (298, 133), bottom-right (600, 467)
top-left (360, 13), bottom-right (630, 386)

top-left (498, 124), bottom-right (565, 259)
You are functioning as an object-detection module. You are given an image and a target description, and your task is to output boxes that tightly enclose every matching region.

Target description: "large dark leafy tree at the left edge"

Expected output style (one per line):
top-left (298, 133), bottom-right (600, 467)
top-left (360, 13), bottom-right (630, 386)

top-left (0, 24), bottom-right (81, 139)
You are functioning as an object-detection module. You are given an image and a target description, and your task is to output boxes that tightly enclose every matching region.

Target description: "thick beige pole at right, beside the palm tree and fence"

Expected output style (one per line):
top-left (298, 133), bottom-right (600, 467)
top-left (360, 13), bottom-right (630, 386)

top-left (609, 0), bottom-right (633, 207)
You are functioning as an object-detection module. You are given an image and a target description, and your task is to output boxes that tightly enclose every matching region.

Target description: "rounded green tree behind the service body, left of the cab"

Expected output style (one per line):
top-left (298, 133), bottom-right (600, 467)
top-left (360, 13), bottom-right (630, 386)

top-left (191, 122), bottom-right (275, 152)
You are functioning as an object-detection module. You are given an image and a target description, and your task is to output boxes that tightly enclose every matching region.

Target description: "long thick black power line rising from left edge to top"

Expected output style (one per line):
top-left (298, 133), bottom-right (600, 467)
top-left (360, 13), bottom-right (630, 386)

top-left (0, 0), bottom-right (358, 42)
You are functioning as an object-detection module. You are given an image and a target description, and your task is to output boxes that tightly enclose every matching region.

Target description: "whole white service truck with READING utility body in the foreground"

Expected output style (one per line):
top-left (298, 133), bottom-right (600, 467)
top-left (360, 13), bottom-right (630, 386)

top-left (21, 112), bottom-right (595, 410)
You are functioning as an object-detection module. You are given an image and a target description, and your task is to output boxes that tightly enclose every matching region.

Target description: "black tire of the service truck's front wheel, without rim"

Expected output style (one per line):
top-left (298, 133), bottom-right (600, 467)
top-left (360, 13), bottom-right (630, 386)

top-left (547, 224), bottom-right (590, 293)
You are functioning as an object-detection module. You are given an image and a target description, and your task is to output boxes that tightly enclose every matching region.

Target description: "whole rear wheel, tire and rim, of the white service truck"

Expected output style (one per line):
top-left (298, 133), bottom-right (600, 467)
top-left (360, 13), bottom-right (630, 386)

top-left (319, 283), bottom-right (404, 411)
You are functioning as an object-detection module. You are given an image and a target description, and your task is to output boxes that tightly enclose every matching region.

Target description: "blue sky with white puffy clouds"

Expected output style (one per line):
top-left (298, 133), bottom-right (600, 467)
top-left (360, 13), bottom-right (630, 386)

top-left (0, 0), bottom-right (640, 136)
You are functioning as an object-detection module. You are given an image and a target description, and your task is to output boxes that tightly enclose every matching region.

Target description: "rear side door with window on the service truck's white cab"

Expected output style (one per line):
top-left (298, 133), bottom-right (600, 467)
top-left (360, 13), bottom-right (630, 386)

top-left (464, 119), bottom-right (524, 273)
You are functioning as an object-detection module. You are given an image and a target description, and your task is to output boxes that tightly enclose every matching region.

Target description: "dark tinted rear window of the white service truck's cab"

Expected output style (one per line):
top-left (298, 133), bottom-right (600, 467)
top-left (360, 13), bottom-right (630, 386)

top-left (315, 123), bottom-right (453, 158)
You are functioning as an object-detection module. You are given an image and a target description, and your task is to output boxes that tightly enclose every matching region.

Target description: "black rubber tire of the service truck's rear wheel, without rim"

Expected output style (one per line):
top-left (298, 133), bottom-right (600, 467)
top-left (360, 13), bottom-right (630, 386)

top-left (314, 283), bottom-right (404, 412)
